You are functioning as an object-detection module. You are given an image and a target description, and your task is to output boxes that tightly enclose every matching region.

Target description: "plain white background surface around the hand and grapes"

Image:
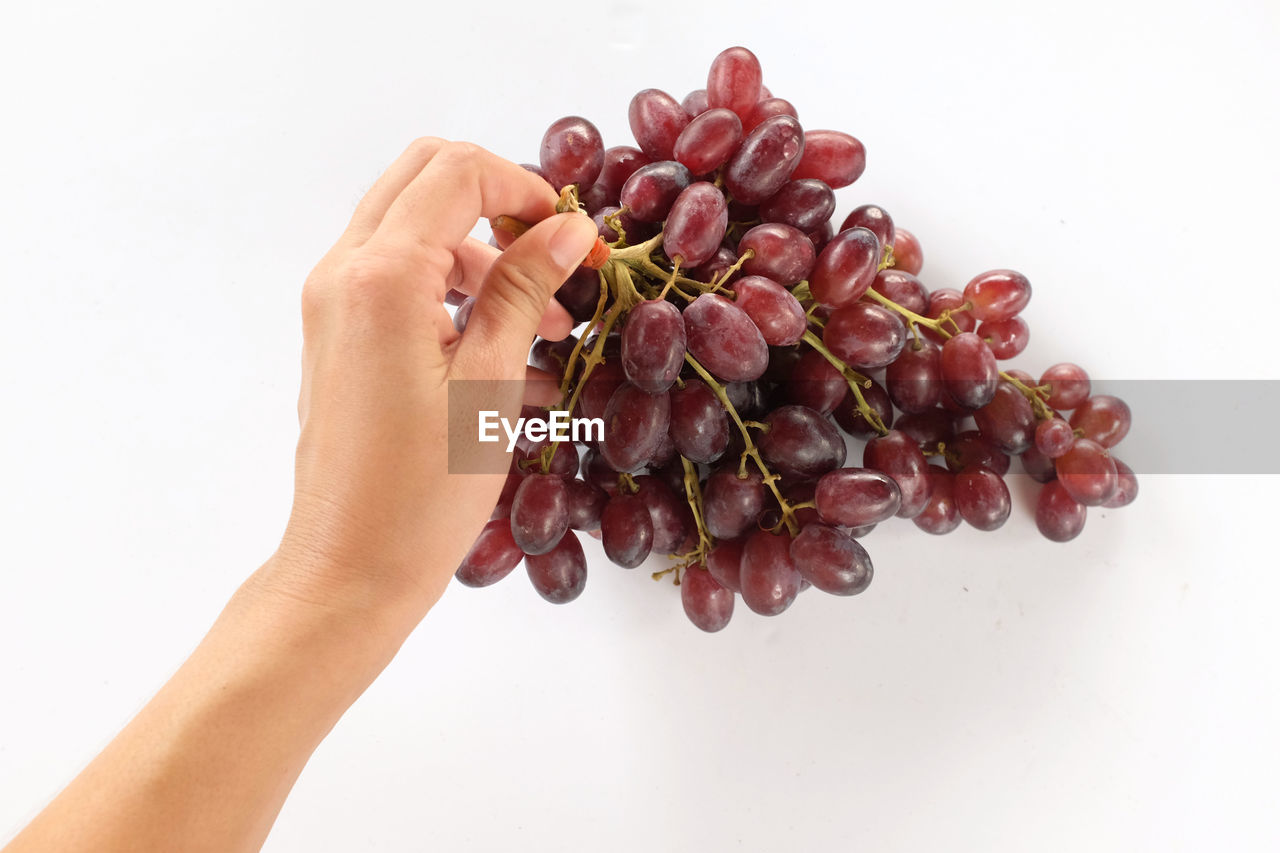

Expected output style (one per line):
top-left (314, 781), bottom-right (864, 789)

top-left (0, 0), bottom-right (1280, 852)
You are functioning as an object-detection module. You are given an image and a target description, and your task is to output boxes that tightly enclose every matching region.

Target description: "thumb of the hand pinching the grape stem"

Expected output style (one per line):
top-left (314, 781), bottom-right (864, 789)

top-left (454, 213), bottom-right (599, 379)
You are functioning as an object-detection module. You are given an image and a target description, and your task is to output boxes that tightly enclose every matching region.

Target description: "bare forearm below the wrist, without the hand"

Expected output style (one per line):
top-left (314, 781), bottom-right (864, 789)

top-left (6, 561), bottom-right (421, 853)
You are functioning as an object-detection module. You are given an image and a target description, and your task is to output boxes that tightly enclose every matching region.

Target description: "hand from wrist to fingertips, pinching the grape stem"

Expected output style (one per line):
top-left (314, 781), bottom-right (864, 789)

top-left (264, 138), bottom-right (596, 624)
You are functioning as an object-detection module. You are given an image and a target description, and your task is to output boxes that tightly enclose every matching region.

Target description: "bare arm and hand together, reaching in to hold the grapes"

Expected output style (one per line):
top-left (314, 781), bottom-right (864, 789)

top-left (4, 138), bottom-right (596, 853)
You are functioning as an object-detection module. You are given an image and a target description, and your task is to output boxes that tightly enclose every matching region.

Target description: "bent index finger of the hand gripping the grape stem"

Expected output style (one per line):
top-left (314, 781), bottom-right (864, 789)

top-left (374, 142), bottom-right (558, 251)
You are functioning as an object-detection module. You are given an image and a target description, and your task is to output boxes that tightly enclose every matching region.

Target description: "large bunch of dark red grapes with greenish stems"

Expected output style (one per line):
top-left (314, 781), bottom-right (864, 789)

top-left (456, 47), bottom-right (1138, 631)
